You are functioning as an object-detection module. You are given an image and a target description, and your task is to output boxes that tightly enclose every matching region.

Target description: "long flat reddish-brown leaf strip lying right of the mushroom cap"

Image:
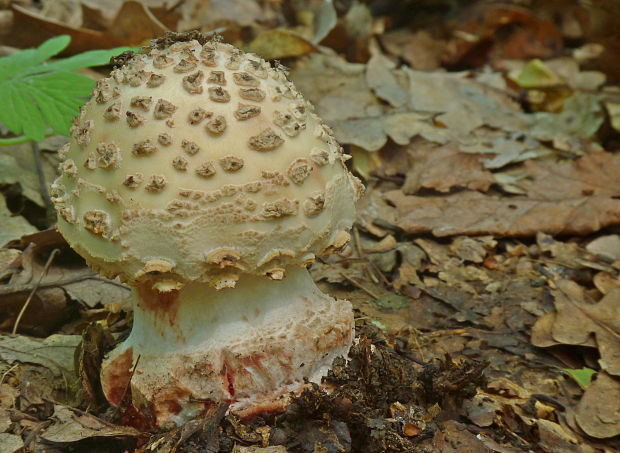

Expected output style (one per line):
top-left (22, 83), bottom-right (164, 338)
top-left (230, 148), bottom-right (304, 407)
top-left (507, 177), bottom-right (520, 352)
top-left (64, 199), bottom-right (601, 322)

top-left (384, 190), bottom-right (620, 237)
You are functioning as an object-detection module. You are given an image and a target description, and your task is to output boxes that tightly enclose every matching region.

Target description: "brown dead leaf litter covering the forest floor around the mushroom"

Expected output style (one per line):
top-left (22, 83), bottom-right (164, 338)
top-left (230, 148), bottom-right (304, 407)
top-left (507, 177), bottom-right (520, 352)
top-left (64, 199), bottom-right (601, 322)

top-left (0, 0), bottom-right (620, 453)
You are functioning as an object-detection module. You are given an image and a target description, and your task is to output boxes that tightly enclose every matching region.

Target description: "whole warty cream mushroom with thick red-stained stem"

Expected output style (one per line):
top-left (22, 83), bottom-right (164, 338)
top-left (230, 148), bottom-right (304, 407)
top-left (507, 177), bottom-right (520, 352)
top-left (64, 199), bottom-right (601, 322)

top-left (52, 40), bottom-right (363, 425)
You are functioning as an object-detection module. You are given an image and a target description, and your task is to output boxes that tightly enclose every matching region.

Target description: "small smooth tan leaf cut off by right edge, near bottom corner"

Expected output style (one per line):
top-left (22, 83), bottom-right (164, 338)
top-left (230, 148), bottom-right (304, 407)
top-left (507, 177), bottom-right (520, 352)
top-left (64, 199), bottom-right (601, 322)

top-left (575, 373), bottom-right (620, 439)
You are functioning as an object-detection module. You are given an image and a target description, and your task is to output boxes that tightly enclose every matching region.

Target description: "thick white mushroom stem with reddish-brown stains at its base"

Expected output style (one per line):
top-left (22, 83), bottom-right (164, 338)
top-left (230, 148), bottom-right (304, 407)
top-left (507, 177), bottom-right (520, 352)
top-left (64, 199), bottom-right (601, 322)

top-left (102, 267), bottom-right (354, 425)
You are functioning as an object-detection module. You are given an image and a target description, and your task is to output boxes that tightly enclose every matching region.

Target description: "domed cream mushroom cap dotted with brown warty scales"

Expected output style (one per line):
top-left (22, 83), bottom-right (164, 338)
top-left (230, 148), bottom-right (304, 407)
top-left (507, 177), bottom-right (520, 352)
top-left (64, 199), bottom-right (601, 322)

top-left (52, 41), bottom-right (363, 290)
